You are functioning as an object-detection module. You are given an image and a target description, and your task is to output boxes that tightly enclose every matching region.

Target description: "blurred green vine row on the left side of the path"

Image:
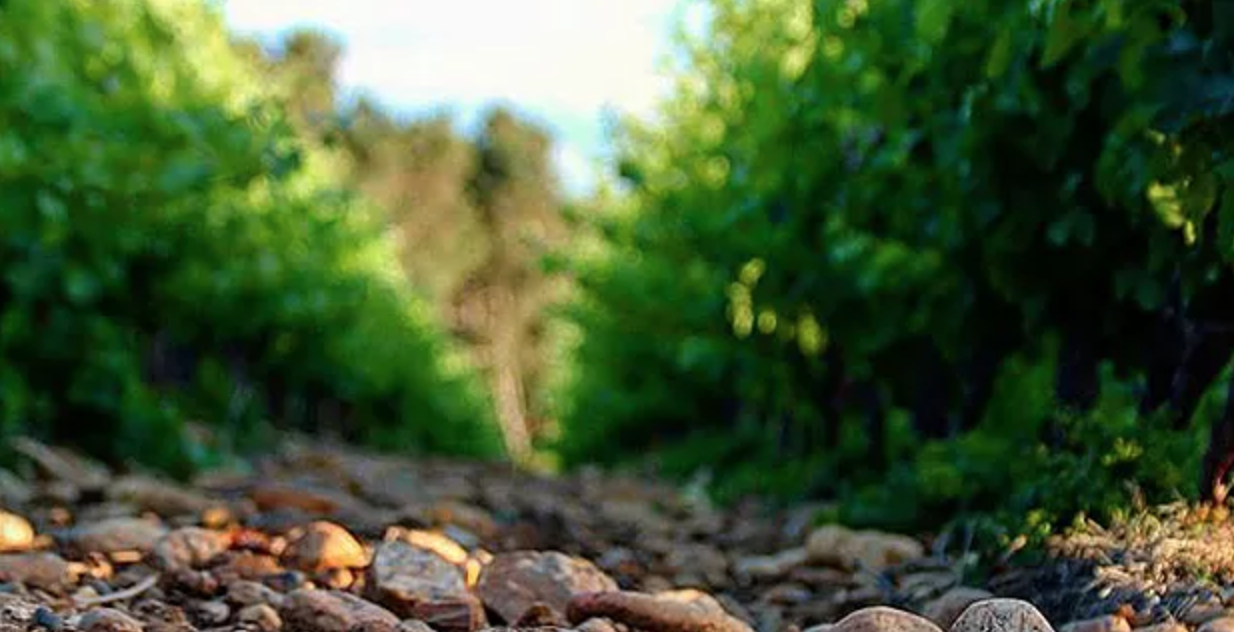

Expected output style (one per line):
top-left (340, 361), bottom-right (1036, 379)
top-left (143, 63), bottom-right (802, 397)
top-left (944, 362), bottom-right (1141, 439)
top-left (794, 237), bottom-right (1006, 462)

top-left (0, 0), bottom-right (500, 472)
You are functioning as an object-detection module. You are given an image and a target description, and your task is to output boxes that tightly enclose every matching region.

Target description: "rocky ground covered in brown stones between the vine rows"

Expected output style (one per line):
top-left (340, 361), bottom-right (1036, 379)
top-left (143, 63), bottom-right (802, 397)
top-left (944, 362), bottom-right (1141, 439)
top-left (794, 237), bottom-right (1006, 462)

top-left (0, 441), bottom-right (1234, 632)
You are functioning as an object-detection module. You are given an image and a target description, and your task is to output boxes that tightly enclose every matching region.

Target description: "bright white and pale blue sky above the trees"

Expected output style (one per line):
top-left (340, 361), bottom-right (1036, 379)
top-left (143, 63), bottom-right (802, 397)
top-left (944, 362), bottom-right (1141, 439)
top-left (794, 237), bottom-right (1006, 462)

top-left (223, 0), bottom-right (677, 197)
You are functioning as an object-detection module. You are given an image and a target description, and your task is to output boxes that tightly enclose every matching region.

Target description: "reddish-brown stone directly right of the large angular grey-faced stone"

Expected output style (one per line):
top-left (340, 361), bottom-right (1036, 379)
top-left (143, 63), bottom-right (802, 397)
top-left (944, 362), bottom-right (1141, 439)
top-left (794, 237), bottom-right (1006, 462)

top-left (476, 552), bottom-right (617, 623)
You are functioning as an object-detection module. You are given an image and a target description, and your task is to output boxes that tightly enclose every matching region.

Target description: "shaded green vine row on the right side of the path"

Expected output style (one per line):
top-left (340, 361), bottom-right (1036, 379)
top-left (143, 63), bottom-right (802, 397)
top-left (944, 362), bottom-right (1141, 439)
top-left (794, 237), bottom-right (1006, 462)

top-left (560, 0), bottom-right (1234, 527)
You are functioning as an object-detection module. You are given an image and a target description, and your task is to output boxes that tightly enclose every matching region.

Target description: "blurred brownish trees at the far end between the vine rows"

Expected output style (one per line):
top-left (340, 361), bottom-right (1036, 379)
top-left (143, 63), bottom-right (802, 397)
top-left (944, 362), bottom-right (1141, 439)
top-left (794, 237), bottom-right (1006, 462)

top-left (238, 31), bottom-right (565, 457)
